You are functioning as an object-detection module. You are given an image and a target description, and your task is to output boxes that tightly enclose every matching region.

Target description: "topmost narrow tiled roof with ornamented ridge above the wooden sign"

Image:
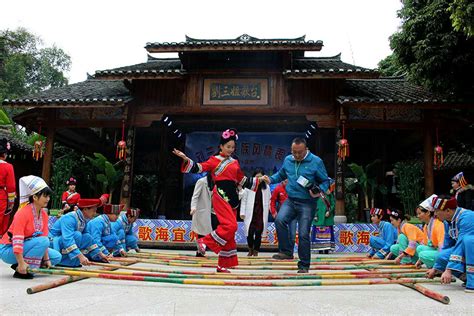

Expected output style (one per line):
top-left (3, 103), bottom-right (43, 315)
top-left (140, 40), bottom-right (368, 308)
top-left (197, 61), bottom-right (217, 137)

top-left (145, 34), bottom-right (323, 53)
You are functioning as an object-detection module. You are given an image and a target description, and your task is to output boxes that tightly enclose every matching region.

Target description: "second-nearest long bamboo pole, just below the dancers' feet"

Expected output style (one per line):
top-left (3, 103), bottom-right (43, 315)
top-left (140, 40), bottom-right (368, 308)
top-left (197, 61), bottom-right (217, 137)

top-left (92, 262), bottom-right (426, 276)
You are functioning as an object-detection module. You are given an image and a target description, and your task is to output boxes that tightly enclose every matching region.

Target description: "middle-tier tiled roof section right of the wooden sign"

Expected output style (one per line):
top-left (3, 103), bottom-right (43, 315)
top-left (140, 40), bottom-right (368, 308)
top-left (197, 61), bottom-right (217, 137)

top-left (283, 54), bottom-right (379, 78)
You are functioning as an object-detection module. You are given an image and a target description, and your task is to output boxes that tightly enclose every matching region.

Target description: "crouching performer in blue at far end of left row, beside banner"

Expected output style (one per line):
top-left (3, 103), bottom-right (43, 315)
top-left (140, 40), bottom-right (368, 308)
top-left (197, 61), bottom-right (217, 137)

top-left (112, 208), bottom-right (140, 255)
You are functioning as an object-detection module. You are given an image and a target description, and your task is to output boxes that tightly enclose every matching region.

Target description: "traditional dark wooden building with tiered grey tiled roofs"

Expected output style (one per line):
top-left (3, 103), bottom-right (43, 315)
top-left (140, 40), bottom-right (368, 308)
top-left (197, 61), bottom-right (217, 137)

top-left (3, 34), bottom-right (472, 220)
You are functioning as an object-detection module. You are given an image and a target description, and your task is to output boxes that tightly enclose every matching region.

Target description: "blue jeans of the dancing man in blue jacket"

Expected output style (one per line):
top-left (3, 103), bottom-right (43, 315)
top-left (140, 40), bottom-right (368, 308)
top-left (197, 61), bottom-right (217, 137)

top-left (275, 198), bottom-right (316, 268)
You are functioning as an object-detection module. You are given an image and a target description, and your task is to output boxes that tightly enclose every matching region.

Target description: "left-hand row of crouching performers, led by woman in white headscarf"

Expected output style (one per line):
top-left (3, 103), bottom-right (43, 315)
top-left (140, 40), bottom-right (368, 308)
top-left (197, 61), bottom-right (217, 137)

top-left (0, 172), bottom-right (140, 279)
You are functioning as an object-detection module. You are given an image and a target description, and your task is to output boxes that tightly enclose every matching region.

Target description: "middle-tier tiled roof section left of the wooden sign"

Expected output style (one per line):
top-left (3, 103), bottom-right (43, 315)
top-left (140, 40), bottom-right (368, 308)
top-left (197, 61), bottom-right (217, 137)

top-left (94, 56), bottom-right (185, 79)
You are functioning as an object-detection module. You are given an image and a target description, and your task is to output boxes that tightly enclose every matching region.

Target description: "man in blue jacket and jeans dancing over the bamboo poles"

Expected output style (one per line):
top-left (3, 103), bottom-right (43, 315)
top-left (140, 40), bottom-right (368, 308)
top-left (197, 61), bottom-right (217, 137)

top-left (262, 138), bottom-right (329, 273)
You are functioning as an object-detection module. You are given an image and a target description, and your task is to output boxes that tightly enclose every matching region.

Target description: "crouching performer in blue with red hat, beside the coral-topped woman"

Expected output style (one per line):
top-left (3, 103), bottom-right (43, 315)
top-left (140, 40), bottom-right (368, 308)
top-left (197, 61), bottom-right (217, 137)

top-left (49, 194), bottom-right (109, 267)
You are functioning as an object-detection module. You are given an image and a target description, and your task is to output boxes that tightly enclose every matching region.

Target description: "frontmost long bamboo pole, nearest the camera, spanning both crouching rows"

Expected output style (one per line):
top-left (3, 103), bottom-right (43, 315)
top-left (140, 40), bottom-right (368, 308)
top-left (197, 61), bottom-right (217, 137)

top-left (29, 269), bottom-right (448, 287)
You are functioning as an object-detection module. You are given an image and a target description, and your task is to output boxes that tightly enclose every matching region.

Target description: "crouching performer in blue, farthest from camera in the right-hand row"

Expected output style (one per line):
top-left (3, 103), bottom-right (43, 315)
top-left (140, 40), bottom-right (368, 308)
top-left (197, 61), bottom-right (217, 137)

top-left (367, 208), bottom-right (398, 259)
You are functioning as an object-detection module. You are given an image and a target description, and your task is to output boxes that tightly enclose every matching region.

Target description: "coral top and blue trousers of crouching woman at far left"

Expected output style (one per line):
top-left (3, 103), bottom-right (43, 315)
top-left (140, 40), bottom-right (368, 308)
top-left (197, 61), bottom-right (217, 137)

top-left (0, 204), bottom-right (61, 268)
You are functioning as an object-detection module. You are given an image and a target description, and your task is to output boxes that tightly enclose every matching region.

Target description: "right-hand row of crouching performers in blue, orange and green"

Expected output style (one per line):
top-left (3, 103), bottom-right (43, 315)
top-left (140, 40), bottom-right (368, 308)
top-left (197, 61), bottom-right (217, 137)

top-left (368, 173), bottom-right (474, 292)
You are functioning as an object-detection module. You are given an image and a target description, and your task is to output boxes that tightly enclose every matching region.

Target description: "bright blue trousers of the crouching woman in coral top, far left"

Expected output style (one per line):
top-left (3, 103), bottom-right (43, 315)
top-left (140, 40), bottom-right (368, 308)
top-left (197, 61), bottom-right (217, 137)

top-left (0, 236), bottom-right (61, 268)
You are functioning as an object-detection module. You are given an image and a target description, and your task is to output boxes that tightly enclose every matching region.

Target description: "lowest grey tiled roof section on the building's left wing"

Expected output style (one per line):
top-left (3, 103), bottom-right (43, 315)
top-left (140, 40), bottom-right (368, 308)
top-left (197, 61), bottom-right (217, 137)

top-left (2, 79), bottom-right (131, 107)
